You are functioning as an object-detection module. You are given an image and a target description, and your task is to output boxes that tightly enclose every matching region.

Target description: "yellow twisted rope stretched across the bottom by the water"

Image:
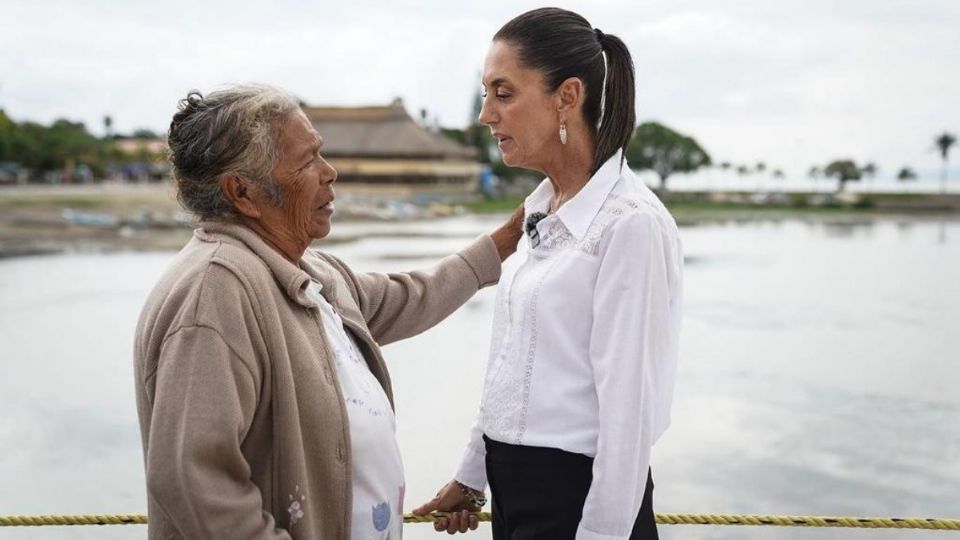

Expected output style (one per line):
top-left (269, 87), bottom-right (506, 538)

top-left (0, 512), bottom-right (960, 531)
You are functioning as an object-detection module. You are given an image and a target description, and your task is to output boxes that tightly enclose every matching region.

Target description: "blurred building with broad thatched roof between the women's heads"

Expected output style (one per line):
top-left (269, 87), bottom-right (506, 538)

top-left (304, 99), bottom-right (481, 191)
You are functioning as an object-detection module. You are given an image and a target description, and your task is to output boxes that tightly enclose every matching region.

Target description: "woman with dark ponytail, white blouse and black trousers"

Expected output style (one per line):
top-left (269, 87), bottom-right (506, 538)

top-left (414, 8), bottom-right (683, 540)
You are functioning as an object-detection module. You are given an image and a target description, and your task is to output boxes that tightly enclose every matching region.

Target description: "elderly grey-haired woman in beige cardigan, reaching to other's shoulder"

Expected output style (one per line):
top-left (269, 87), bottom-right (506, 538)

top-left (135, 87), bottom-right (520, 540)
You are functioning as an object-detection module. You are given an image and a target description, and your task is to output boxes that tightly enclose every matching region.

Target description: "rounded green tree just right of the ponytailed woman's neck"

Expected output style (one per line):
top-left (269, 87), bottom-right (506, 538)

top-left (626, 122), bottom-right (710, 189)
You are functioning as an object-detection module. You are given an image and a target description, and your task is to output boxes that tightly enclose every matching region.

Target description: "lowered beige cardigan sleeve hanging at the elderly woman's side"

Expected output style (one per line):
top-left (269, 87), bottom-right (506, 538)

top-left (145, 325), bottom-right (290, 540)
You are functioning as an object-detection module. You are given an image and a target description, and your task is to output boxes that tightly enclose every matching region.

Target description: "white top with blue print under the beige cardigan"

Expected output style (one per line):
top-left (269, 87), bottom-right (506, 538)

top-left (306, 281), bottom-right (405, 540)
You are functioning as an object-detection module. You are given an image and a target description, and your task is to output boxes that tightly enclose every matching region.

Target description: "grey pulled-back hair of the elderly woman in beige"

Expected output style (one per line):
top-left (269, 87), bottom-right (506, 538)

top-left (167, 85), bottom-right (300, 221)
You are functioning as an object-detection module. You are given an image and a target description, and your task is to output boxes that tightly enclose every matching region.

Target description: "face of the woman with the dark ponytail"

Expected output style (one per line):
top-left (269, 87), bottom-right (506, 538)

top-left (479, 41), bottom-right (560, 171)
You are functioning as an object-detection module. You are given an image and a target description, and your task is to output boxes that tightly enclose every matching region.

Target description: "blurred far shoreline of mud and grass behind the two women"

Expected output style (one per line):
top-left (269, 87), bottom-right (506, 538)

top-left (0, 184), bottom-right (960, 260)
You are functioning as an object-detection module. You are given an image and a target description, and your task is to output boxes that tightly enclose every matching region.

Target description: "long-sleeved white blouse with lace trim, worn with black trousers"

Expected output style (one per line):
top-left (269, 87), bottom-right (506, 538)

top-left (455, 152), bottom-right (683, 540)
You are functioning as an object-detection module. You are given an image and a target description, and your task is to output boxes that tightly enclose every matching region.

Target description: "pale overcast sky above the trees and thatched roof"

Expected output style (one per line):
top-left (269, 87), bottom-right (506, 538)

top-left (0, 0), bottom-right (960, 175)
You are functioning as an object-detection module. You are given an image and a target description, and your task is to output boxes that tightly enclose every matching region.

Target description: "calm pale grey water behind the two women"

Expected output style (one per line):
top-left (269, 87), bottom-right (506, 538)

top-left (0, 213), bottom-right (960, 540)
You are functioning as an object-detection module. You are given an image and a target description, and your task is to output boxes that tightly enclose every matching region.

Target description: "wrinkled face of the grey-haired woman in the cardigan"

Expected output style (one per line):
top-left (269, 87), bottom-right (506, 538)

top-left (260, 111), bottom-right (337, 245)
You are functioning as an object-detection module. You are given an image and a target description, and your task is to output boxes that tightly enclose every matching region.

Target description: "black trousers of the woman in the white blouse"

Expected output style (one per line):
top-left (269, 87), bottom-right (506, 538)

top-left (483, 436), bottom-right (659, 540)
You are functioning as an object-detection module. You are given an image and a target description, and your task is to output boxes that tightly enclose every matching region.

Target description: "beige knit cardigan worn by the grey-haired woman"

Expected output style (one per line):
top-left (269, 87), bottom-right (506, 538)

top-left (134, 223), bottom-right (500, 540)
